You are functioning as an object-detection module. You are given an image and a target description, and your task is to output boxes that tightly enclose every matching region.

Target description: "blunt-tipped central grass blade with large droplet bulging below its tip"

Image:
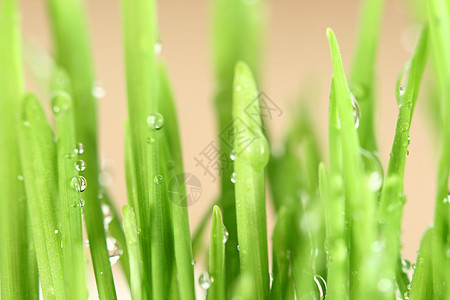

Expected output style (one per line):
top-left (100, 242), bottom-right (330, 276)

top-left (232, 62), bottom-right (269, 299)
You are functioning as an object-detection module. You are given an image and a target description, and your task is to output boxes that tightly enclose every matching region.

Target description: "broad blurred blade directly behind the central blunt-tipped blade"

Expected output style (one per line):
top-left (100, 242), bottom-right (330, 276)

top-left (212, 0), bottom-right (266, 286)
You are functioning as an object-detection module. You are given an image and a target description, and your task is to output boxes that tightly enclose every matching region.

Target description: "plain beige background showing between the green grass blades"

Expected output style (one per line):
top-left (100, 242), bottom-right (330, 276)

top-left (21, 0), bottom-right (438, 296)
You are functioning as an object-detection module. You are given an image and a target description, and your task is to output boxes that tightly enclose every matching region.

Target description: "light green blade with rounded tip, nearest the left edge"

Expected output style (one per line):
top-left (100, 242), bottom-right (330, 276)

top-left (19, 94), bottom-right (65, 299)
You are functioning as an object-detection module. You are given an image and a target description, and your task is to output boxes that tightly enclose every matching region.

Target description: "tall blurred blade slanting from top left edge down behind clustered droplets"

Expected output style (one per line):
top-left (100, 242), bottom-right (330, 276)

top-left (47, 0), bottom-right (115, 299)
